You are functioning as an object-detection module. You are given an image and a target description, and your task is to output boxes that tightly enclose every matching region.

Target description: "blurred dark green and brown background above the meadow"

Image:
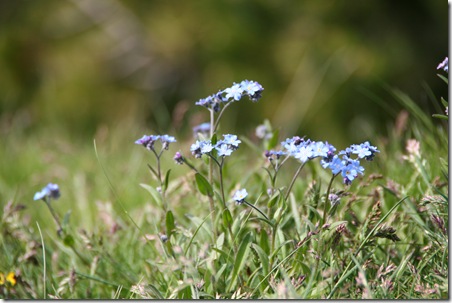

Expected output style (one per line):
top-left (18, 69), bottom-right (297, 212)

top-left (0, 0), bottom-right (448, 148)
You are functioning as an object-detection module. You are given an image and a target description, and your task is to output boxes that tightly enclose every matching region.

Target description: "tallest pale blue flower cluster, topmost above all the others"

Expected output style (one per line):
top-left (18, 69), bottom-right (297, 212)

top-left (195, 80), bottom-right (264, 112)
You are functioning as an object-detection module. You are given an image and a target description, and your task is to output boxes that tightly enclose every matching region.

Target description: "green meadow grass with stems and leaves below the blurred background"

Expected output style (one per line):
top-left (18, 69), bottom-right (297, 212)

top-left (0, 77), bottom-right (449, 299)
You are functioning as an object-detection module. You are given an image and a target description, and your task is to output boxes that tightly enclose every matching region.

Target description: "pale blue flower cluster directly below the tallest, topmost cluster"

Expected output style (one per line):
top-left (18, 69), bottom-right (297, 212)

top-left (190, 134), bottom-right (242, 158)
